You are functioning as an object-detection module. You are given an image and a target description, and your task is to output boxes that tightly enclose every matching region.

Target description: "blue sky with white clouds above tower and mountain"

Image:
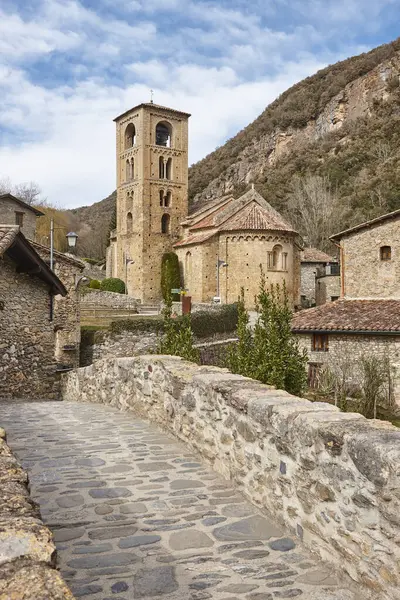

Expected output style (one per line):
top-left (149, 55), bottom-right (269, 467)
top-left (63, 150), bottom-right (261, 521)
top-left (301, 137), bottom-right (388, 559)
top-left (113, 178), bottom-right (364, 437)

top-left (0, 0), bottom-right (400, 207)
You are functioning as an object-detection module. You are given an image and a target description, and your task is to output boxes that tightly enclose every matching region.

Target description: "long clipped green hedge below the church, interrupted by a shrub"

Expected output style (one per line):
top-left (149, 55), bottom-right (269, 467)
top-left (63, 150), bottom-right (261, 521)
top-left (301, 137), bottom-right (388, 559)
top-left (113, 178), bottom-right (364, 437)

top-left (110, 304), bottom-right (238, 338)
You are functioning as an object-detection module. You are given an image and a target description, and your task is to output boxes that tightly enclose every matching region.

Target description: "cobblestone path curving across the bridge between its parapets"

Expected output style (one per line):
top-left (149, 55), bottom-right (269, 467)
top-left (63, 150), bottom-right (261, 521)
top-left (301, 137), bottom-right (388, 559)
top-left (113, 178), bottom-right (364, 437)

top-left (0, 402), bottom-right (363, 600)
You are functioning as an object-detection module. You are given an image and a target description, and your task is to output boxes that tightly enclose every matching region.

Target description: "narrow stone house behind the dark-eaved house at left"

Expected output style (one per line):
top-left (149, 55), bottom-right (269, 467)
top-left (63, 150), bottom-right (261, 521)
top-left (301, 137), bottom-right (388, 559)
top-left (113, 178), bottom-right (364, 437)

top-left (32, 242), bottom-right (85, 367)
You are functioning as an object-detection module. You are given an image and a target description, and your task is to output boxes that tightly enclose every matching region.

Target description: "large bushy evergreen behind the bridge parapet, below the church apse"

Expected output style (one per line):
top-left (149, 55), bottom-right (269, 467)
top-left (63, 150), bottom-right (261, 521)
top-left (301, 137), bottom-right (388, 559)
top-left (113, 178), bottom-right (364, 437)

top-left (228, 267), bottom-right (307, 395)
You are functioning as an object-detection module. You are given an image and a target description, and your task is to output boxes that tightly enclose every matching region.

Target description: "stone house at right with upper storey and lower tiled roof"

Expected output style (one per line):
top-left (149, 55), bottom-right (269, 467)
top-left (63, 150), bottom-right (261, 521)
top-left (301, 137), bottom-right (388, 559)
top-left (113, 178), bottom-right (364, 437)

top-left (292, 210), bottom-right (400, 412)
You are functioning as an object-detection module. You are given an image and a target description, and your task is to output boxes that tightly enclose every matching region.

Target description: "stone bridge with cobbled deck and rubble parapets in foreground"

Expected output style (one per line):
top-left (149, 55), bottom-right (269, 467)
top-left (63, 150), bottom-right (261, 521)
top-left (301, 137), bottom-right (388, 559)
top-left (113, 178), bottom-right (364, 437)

top-left (0, 356), bottom-right (400, 600)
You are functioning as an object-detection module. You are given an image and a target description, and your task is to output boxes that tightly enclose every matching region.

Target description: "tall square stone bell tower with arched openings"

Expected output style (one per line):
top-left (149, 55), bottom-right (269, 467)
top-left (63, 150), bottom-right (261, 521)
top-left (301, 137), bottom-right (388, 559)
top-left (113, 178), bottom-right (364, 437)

top-left (113, 102), bottom-right (190, 303)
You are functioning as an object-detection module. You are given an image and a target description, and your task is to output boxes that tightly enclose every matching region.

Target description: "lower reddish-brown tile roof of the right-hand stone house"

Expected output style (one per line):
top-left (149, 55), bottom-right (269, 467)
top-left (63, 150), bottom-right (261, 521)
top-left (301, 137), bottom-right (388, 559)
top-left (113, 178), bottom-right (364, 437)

top-left (292, 300), bottom-right (400, 333)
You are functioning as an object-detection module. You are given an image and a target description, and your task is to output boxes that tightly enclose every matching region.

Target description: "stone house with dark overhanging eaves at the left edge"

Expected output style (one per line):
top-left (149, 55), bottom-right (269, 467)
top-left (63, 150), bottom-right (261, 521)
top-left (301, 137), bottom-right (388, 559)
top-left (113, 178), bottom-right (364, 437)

top-left (0, 225), bottom-right (67, 398)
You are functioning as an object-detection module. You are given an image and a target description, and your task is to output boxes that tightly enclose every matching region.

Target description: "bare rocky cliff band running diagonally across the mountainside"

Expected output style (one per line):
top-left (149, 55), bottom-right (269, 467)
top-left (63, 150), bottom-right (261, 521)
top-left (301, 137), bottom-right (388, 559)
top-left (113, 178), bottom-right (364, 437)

top-left (191, 51), bottom-right (400, 210)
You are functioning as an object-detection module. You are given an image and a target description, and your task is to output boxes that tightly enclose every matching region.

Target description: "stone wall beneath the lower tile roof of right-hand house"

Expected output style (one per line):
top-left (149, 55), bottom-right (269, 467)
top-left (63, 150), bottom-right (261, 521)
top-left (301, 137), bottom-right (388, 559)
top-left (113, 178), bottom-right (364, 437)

top-left (296, 333), bottom-right (400, 414)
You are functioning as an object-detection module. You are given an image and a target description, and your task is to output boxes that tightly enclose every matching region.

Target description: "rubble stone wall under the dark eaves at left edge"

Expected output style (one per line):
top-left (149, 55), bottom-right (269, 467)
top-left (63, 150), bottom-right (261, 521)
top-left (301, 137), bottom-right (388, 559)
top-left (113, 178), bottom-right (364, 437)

top-left (0, 256), bottom-right (59, 399)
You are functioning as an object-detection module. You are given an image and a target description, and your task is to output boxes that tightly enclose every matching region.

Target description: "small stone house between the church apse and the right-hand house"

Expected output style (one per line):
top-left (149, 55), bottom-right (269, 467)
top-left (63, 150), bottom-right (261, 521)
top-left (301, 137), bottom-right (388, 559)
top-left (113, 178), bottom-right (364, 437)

top-left (300, 248), bottom-right (340, 308)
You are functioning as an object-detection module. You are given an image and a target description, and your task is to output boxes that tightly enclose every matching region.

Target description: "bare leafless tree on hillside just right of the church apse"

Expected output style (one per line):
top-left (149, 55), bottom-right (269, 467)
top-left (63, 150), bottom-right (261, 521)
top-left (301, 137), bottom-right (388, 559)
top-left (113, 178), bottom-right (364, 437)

top-left (288, 175), bottom-right (342, 249)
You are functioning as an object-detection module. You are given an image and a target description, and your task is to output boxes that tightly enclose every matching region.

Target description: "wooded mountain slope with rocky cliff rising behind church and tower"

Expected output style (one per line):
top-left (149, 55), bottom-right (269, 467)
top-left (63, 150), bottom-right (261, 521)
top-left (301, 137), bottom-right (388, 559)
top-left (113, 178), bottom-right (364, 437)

top-left (71, 38), bottom-right (400, 256)
